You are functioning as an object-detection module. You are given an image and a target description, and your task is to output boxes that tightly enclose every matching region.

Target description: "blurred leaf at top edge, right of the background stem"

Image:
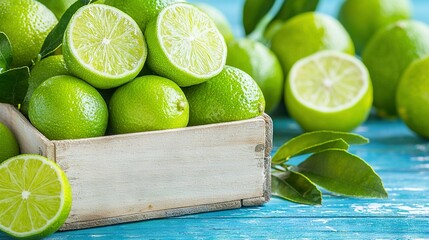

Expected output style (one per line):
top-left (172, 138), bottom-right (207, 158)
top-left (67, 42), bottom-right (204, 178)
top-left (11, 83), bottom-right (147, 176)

top-left (273, 0), bottom-right (319, 21)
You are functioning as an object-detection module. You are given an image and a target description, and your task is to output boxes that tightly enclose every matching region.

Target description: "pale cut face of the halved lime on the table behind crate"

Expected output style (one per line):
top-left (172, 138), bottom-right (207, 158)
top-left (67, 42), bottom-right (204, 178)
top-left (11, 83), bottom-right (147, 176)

top-left (289, 50), bottom-right (370, 112)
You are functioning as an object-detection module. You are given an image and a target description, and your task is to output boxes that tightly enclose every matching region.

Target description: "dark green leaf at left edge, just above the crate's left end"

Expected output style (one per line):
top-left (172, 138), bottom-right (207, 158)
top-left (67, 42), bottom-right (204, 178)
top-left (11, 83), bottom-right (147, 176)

top-left (0, 66), bottom-right (30, 106)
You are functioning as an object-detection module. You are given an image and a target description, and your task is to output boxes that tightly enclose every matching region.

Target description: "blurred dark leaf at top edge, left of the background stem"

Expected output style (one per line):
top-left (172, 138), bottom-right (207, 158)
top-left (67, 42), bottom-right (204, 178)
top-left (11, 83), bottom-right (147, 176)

top-left (243, 0), bottom-right (276, 35)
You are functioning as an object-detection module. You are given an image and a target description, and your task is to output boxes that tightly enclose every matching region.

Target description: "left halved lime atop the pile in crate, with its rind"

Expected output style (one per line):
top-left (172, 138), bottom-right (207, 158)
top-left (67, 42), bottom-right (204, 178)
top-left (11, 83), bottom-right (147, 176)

top-left (62, 4), bottom-right (147, 89)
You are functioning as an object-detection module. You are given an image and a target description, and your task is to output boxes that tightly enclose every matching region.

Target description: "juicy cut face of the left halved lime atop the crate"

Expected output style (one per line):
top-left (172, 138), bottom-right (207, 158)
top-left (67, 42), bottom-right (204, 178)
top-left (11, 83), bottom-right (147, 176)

top-left (67, 4), bottom-right (147, 78)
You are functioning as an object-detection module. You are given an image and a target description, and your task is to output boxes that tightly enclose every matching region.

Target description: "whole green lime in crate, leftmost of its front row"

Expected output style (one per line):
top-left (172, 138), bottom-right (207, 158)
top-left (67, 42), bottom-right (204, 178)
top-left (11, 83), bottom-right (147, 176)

top-left (28, 75), bottom-right (108, 140)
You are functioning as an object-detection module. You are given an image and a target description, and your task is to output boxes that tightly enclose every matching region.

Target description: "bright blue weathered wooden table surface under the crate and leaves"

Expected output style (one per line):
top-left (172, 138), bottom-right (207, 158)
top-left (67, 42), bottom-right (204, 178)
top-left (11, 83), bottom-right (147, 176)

top-left (0, 0), bottom-right (429, 240)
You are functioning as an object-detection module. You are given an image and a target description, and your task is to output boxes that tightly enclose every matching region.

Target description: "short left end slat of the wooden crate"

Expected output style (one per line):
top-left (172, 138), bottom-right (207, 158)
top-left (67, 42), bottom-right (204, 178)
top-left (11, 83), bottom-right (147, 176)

top-left (0, 103), bottom-right (55, 160)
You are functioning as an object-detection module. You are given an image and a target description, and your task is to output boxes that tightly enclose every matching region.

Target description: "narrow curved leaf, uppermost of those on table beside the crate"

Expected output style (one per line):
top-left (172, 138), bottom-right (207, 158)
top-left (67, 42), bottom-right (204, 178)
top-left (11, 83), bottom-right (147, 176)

top-left (271, 131), bottom-right (369, 164)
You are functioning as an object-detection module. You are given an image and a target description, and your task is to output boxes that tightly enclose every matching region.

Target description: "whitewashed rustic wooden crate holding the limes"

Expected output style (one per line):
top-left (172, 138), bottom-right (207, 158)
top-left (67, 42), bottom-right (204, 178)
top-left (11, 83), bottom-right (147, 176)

top-left (0, 103), bottom-right (272, 230)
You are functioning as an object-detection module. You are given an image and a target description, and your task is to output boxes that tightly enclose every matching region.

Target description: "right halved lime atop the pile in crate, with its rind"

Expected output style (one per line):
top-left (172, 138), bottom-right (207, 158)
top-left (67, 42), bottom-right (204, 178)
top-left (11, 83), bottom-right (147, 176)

top-left (145, 3), bottom-right (227, 87)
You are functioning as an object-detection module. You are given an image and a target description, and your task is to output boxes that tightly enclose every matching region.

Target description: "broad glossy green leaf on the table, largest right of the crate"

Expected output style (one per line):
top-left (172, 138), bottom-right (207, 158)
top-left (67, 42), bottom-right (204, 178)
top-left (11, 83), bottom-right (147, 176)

top-left (295, 149), bottom-right (387, 198)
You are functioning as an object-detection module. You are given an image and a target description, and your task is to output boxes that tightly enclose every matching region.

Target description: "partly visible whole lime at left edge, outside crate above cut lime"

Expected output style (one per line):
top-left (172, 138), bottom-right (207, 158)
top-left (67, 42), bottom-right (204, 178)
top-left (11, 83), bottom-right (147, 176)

top-left (0, 122), bottom-right (19, 163)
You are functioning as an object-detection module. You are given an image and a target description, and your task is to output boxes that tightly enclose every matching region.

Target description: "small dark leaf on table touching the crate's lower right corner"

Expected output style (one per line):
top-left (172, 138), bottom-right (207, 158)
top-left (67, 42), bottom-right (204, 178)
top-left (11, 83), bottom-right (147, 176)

top-left (271, 170), bottom-right (322, 205)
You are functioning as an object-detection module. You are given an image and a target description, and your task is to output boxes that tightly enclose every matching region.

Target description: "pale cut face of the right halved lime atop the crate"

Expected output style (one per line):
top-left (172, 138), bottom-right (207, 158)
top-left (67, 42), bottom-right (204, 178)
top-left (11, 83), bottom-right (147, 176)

top-left (157, 4), bottom-right (226, 77)
